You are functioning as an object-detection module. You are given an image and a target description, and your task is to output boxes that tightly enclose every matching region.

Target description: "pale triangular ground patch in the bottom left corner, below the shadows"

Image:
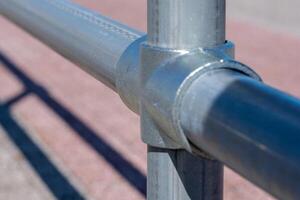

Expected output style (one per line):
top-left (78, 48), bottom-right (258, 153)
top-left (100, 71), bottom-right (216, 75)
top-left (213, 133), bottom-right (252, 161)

top-left (0, 126), bottom-right (53, 200)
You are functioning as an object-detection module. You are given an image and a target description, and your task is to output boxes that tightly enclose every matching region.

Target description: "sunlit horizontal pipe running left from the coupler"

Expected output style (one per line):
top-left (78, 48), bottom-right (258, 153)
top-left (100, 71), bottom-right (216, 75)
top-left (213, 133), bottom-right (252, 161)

top-left (0, 0), bottom-right (143, 90)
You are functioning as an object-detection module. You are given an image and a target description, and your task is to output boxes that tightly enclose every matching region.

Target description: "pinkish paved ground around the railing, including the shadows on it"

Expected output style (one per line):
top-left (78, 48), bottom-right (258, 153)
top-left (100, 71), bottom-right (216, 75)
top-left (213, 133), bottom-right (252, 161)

top-left (0, 0), bottom-right (300, 200)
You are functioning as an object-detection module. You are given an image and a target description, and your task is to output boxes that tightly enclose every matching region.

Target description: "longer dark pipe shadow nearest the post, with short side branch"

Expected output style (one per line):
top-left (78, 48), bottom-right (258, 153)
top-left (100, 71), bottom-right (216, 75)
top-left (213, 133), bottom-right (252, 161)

top-left (0, 52), bottom-right (146, 196)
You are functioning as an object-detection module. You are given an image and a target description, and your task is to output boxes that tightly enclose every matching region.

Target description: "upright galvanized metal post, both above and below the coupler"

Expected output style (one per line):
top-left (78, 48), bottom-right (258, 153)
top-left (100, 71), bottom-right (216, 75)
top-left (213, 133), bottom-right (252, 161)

top-left (147, 0), bottom-right (225, 200)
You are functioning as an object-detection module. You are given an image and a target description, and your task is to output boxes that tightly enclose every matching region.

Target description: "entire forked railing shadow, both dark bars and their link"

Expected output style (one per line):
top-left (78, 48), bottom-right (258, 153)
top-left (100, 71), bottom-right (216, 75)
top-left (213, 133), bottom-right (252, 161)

top-left (0, 52), bottom-right (146, 199)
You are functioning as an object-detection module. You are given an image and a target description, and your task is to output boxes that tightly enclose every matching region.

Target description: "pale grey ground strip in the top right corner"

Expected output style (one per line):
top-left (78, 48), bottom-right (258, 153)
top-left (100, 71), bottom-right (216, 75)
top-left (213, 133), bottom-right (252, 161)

top-left (227, 0), bottom-right (300, 37)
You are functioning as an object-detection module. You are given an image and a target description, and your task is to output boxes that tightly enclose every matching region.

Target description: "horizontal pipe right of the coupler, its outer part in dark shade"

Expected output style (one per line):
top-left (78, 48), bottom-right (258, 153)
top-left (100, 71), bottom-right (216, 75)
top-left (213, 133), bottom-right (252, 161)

top-left (181, 71), bottom-right (300, 199)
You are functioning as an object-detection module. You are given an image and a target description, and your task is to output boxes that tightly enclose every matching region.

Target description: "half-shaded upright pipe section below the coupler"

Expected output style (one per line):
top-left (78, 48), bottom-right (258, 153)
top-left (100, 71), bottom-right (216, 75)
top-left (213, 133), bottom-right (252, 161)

top-left (147, 147), bottom-right (223, 200)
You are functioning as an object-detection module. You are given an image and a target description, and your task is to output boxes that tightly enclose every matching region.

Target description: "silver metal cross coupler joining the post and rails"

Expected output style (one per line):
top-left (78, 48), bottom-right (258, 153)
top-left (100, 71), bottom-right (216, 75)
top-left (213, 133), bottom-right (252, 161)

top-left (116, 37), bottom-right (261, 152)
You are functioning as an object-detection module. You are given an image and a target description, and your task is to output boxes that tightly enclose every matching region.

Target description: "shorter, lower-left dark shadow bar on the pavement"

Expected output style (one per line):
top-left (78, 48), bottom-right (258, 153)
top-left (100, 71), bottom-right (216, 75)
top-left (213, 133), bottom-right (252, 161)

top-left (0, 104), bottom-right (84, 200)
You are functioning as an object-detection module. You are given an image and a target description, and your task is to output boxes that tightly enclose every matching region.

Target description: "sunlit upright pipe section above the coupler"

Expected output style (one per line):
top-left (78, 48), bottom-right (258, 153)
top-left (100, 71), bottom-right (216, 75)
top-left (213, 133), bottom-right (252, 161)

top-left (148, 0), bottom-right (226, 50)
